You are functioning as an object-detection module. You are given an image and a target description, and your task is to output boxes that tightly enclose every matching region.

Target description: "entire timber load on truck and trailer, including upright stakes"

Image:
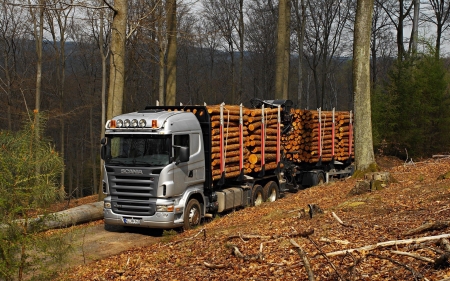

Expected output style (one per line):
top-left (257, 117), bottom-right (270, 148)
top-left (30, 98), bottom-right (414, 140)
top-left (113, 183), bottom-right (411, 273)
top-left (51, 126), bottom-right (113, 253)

top-left (185, 105), bottom-right (354, 180)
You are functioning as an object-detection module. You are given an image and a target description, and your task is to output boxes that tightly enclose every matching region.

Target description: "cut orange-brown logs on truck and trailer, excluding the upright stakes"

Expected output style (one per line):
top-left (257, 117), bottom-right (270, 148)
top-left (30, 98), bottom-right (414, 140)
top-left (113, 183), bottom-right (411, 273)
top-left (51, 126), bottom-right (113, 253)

top-left (202, 105), bottom-right (353, 180)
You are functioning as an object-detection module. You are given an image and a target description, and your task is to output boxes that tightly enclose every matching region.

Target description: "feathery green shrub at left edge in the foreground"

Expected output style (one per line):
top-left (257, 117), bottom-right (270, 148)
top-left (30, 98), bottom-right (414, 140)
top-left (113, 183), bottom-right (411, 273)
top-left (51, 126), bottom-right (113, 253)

top-left (0, 113), bottom-right (67, 280)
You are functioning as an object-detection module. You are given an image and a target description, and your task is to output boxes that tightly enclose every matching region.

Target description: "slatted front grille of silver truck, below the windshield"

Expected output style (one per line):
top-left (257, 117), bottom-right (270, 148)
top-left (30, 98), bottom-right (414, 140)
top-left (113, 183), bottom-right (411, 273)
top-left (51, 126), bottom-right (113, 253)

top-left (106, 167), bottom-right (159, 216)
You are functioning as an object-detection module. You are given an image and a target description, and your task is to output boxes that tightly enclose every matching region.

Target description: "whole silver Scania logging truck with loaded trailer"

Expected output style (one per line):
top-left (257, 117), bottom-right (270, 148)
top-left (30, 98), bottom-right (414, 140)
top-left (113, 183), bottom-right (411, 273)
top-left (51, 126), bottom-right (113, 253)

top-left (101, 99), bottom-right (353, 229)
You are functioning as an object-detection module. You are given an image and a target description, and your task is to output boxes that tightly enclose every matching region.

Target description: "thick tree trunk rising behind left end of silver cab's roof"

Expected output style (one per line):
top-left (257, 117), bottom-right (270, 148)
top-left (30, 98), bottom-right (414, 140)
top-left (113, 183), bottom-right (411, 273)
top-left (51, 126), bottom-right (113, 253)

top-left (107, 0), bottom-right (128, 119)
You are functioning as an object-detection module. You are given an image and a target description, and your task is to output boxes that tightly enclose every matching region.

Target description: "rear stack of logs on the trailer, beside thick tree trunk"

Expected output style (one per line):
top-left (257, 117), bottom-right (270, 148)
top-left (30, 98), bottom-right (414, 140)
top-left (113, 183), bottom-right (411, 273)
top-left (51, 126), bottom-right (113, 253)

top-left (283, 109), bottom-right (354, 163)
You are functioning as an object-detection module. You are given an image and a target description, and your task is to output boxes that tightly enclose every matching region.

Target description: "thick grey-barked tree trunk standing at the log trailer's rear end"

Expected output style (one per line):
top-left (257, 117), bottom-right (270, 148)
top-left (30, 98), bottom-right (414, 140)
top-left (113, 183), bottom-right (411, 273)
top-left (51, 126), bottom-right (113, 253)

top-left (353, 0), bottom-right (375, 170)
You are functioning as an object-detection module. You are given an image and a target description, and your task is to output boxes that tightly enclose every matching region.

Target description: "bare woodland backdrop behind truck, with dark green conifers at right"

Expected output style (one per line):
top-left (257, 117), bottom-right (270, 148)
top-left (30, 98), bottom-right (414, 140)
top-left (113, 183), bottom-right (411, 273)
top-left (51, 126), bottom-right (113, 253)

top-left (0, 0), bottom-right (450, 197)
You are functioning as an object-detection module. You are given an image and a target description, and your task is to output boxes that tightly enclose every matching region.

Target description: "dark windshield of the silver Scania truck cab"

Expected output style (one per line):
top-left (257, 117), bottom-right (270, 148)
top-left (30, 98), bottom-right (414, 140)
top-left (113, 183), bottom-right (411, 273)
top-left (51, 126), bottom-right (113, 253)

top-left (105, 135), bottom-right (172, 166)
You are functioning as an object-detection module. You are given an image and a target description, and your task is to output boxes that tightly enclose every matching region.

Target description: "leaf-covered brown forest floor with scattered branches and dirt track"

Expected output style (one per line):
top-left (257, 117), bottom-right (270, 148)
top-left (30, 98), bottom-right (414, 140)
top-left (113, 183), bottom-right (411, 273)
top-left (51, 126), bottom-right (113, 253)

top-left (50, 157), bottom-right (450, 281)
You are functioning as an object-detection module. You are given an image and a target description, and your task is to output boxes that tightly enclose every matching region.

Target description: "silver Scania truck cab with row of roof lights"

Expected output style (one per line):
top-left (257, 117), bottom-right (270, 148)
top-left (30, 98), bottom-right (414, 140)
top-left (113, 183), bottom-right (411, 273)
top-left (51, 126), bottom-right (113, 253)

top-left (101, 110), bottom-right (205, 228)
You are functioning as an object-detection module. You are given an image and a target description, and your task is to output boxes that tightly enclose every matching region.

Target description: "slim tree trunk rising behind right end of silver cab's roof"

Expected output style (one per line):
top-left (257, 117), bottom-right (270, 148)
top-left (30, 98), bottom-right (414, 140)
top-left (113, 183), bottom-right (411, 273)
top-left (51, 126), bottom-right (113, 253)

top-left (165, 0), bottom-right (177, 105)
